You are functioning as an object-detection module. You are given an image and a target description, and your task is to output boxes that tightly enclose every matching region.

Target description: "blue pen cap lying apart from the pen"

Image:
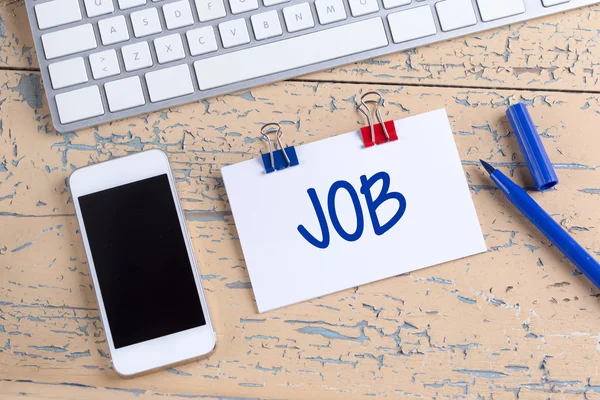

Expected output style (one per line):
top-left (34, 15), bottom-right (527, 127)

top-left (506, 103), bottom-right (558, 190)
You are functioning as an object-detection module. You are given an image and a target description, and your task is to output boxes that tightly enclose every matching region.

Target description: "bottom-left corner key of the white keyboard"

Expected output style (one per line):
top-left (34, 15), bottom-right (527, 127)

top-left (54, 86), bottom-right (104, 124)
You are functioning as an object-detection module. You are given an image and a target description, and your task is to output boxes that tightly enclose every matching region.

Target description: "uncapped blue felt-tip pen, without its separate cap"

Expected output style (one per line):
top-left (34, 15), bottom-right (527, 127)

top-left (480, 160), bottom-right (600, 288)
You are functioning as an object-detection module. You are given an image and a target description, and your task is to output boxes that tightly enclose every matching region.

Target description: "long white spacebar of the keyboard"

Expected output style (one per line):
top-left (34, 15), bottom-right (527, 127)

top-left (194, 18), bottom-right (388, 90)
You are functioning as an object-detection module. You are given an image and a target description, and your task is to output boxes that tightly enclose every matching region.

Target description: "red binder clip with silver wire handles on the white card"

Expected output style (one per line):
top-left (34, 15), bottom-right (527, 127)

top-left (358, 92), bottom-right (398, 147)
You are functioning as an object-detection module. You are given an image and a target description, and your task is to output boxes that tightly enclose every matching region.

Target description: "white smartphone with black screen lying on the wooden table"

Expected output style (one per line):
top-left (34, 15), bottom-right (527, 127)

top-left (70, 150), bottom-right (216, 376)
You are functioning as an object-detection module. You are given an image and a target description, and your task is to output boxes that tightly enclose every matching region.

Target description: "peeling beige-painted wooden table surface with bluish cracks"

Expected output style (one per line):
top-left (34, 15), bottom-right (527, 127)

top-left (0, 0), bottom-right (600, 400)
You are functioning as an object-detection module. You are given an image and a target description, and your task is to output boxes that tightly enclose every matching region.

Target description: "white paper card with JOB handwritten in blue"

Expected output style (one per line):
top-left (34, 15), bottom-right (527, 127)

top-left (222, 110), bottom-right (487, 312)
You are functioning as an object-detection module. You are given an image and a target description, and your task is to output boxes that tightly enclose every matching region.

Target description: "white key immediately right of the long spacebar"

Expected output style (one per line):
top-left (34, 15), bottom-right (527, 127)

top-left (388, 5), bottom-right (436, 43)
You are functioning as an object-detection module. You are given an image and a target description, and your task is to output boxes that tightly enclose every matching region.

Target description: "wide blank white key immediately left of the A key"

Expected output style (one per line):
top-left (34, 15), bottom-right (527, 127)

top-left (42, 24), bottom-right (98, 60)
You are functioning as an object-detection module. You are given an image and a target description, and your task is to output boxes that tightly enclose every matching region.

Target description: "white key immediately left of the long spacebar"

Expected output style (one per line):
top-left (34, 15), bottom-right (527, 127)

top-left (146, 64), bottom-right (193, 103)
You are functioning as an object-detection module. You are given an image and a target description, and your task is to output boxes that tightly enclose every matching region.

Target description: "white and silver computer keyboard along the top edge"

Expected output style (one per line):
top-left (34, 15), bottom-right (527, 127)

top-left (26, 0), bottom-right (600, 132)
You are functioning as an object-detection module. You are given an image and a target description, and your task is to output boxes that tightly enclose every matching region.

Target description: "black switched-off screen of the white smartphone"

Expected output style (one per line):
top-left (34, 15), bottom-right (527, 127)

top-left (79, 174), bottom-right (206, 349)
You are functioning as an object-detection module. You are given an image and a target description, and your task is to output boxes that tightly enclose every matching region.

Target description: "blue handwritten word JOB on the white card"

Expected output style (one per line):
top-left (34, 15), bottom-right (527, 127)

top-left (298, 172), bottom-right (406, 249)
